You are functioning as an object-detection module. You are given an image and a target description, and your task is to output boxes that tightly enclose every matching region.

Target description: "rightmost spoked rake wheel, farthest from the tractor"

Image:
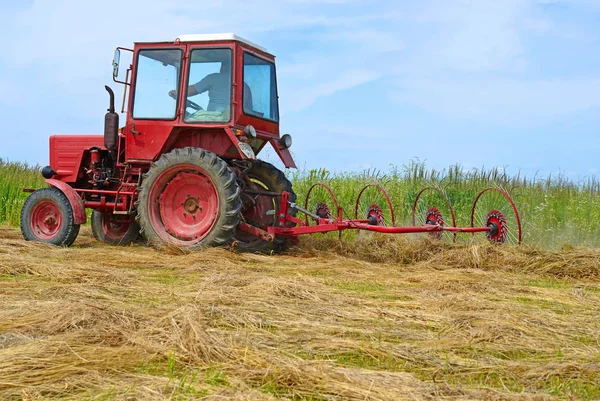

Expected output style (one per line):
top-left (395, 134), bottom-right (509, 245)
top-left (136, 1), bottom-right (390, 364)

top-left (471, 188), bottom-right (523, 245)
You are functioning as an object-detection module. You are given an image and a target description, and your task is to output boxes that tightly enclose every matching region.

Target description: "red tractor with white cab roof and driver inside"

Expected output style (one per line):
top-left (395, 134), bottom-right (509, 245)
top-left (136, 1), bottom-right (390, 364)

top-left (21, 34), bottom-right (296, 251)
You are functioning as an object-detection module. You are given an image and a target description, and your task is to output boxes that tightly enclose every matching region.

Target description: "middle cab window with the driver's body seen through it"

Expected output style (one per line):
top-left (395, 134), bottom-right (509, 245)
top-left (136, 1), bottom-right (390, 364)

top-left (184, 49), bottom-right (231, 123)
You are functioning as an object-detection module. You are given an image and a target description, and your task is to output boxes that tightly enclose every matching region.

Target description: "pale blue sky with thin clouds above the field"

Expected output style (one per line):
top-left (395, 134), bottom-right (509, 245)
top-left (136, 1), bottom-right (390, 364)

top-left (0, 0), bottom-right (600, 179)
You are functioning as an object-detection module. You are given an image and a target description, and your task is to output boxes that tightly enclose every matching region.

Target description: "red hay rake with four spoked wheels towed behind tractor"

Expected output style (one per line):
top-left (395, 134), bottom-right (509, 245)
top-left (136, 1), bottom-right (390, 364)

top-left (263, 183), bottom-right (522, 245)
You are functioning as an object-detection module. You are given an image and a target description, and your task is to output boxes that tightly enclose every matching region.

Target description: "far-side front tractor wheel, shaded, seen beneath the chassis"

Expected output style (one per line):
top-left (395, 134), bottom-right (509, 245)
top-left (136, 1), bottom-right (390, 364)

top-left (92, 210), bottom-right (140, 245)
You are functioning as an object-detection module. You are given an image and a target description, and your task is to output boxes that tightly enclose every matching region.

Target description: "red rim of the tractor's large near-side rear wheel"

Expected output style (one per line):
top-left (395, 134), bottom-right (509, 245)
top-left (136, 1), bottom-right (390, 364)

top-left (148, 164), bottom-right (219, 245)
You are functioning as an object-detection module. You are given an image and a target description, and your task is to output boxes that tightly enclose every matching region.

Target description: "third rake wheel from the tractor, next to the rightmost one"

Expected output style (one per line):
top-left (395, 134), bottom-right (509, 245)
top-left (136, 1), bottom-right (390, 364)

top-left (412, 187), bottom-right (456, 242)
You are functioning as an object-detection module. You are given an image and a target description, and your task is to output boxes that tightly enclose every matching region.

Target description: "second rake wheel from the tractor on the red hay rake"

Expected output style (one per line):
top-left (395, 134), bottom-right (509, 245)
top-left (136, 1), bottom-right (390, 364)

top-left (354, 184), bottom-right (396, 227)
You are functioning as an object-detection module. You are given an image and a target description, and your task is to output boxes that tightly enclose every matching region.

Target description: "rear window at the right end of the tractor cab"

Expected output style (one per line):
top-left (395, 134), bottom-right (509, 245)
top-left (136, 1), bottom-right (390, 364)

top-left (244, 53), bottom-right (279, 122)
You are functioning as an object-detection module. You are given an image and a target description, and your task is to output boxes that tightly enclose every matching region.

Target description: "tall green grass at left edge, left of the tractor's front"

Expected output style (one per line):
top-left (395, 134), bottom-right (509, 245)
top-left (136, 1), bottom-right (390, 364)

top-left (0, 158), bottom-right (45, 225)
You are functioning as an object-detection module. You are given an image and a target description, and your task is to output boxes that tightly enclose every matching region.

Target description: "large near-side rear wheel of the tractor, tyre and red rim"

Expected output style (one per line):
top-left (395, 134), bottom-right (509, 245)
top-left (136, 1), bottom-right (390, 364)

top-left (136, 148), bottom-right (241, 250)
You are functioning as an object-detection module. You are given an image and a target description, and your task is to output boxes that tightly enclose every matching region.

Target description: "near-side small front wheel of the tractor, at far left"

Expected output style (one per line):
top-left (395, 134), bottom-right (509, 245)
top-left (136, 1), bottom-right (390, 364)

top-left (21, 187), bottom-right (79, 246)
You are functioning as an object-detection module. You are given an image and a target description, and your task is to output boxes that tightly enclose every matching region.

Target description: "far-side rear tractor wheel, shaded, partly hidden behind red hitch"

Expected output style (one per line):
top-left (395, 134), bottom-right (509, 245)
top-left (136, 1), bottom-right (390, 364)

top-left (235, 160), bottom-right (296, 252)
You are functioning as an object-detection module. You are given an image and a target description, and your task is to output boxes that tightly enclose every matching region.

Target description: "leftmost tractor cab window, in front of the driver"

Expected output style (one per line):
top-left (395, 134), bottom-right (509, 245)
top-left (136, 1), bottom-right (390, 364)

top-left (133, 49), bottom-right (181, 120)
